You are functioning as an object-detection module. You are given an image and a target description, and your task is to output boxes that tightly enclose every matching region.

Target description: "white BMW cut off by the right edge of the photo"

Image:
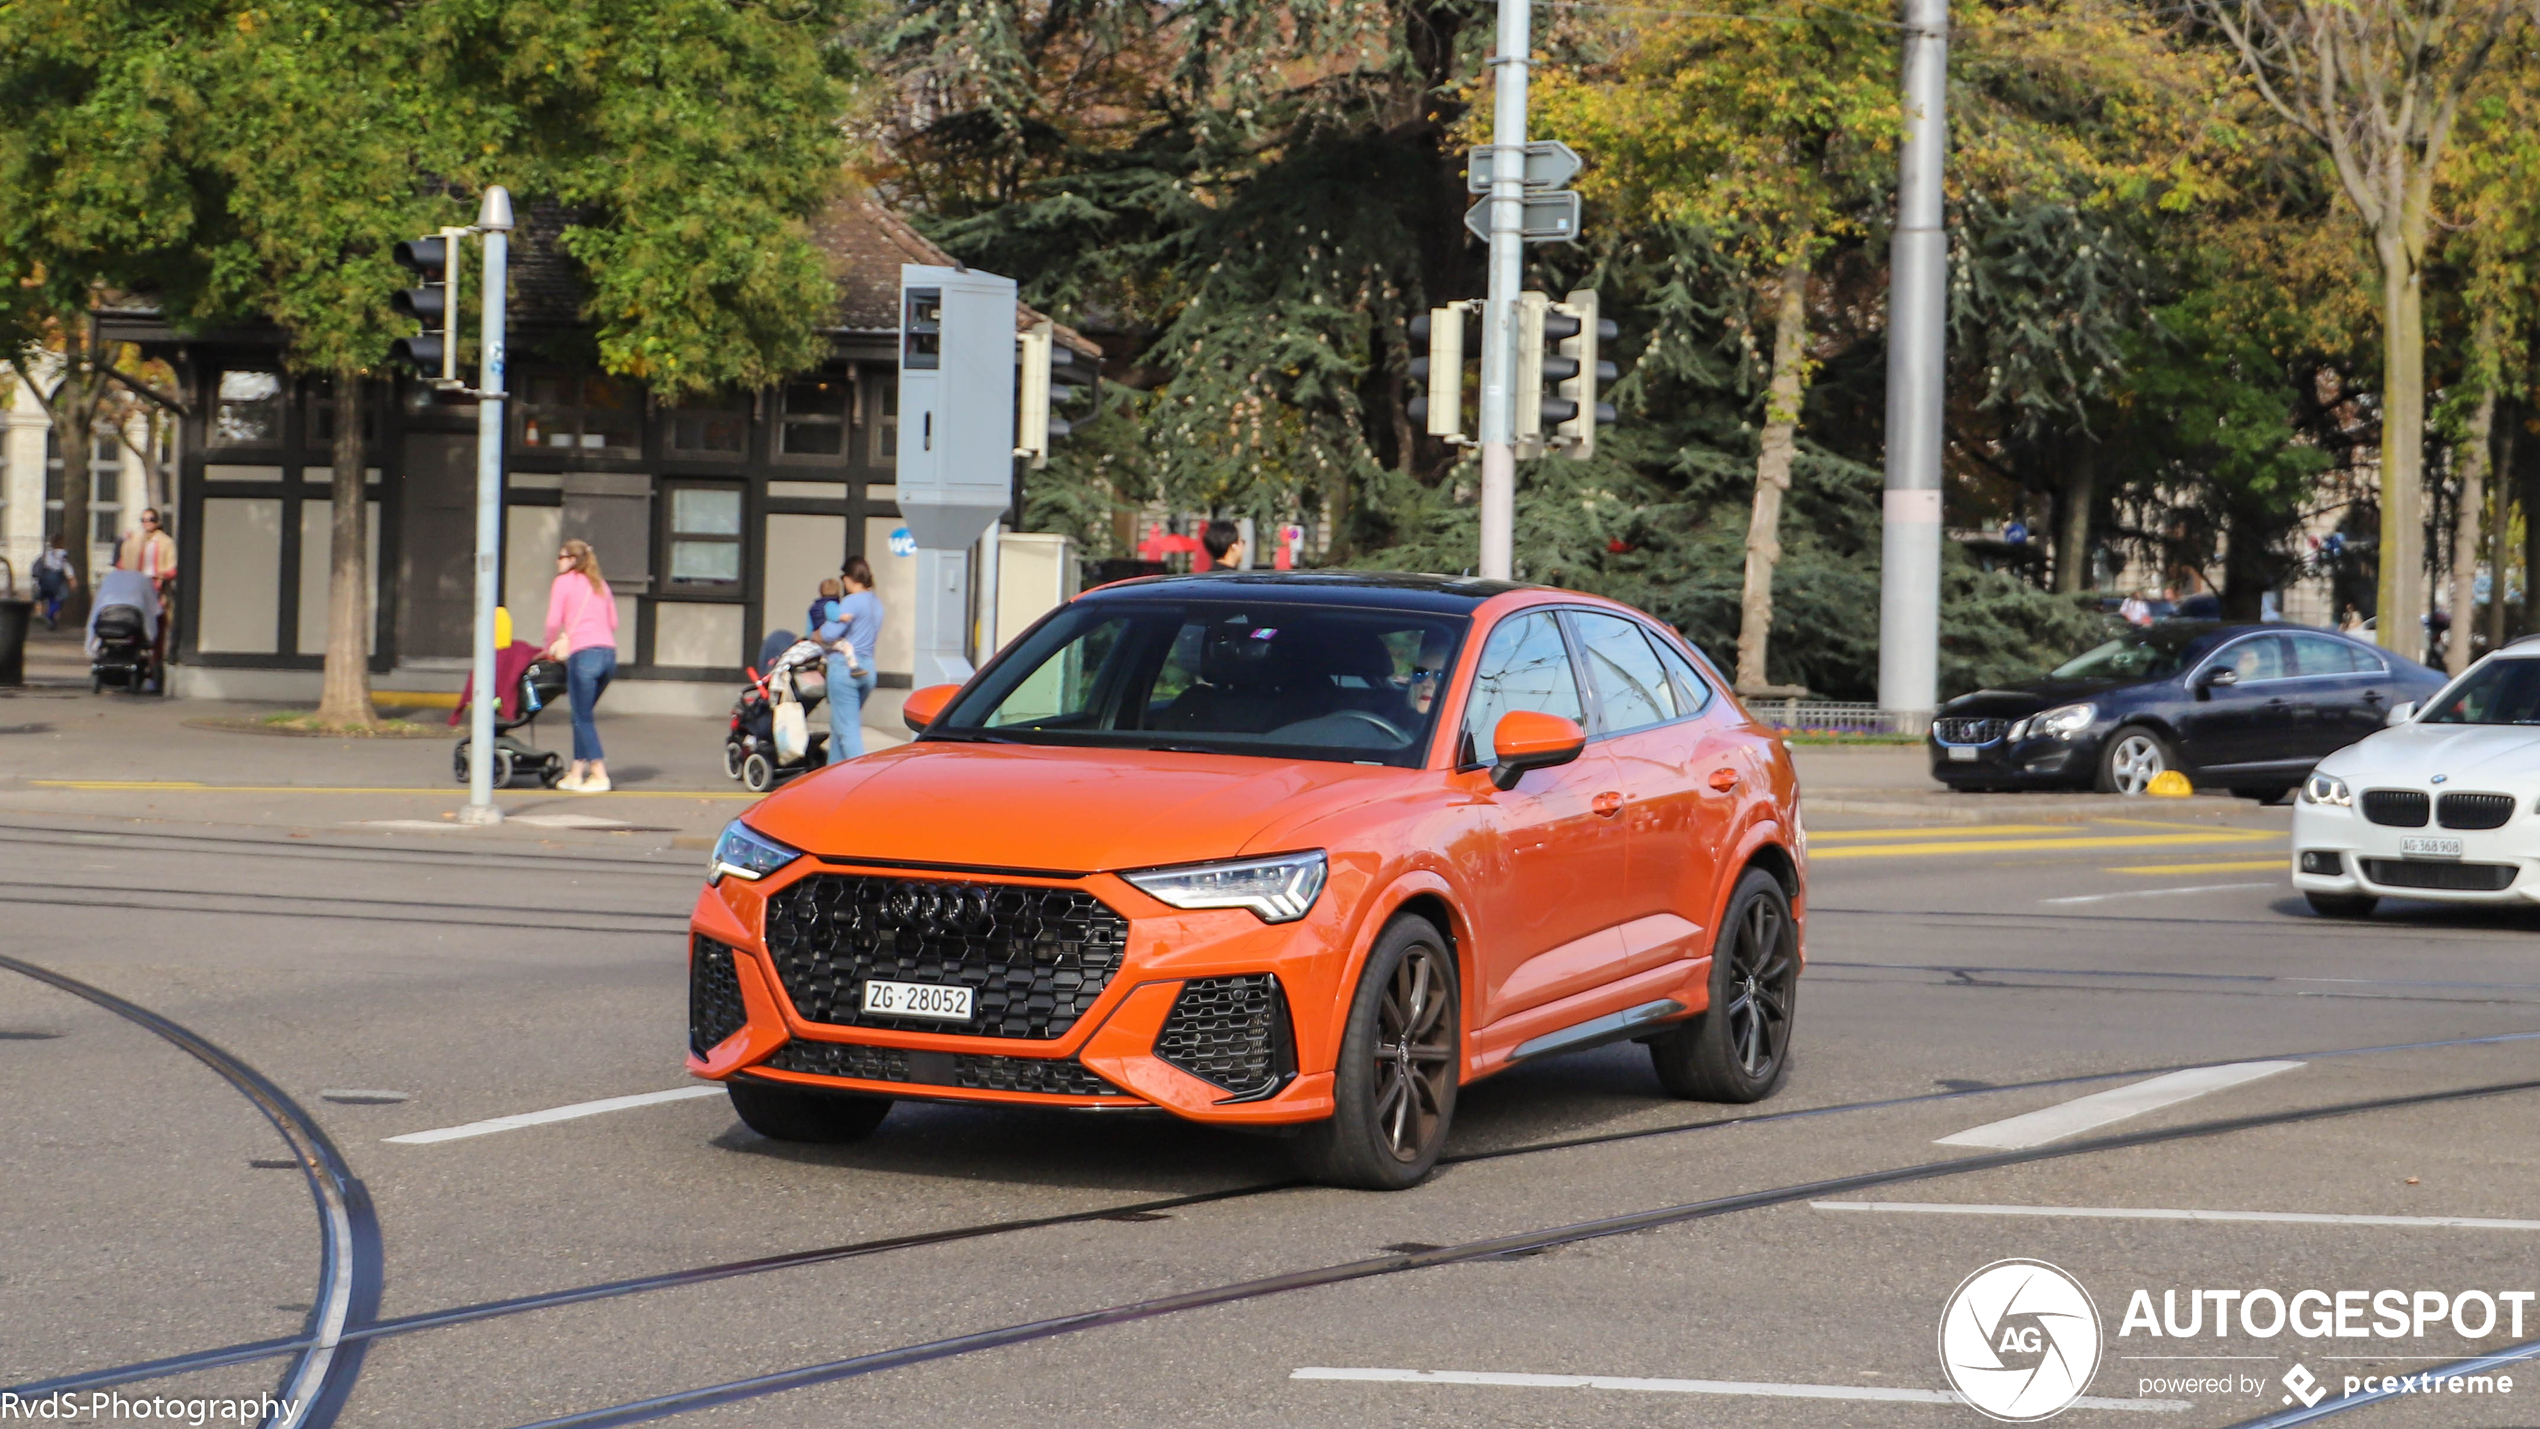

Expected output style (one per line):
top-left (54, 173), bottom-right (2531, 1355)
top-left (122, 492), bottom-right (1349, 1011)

top-left (2294, 642), bottom-right (2540, 919)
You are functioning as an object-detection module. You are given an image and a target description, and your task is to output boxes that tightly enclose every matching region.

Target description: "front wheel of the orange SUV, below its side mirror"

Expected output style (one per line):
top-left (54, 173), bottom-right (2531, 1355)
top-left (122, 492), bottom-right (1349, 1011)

top-left (1295, 916), bottom-right (1463, 1190)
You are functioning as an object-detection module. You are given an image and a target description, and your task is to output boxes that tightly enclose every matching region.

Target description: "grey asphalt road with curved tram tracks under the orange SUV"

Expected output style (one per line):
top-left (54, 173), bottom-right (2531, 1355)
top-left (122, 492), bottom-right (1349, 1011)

top-left (0, 746), bottom-right (2540, 1429)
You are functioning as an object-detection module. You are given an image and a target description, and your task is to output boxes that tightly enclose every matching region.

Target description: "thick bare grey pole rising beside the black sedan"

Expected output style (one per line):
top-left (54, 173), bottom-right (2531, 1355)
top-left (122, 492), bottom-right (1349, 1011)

top-left (1880, 0), bottom-right (1948, 731)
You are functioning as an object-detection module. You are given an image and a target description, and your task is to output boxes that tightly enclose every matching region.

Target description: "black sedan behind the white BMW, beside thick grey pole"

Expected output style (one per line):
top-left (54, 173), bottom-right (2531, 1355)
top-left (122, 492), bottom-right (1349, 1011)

top-left (1928, 619), bottom-right (2443, 800)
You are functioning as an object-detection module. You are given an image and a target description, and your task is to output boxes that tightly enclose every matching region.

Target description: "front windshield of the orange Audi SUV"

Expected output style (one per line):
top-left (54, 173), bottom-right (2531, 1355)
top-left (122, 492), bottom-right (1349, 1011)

top-left (927, 599), bottom-right (1468, 767)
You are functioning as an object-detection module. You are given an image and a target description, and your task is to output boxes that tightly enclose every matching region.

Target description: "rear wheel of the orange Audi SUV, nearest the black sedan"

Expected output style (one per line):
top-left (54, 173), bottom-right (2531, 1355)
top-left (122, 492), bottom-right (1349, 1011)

top-left (1648, 868), bottom-right (1798, 1104)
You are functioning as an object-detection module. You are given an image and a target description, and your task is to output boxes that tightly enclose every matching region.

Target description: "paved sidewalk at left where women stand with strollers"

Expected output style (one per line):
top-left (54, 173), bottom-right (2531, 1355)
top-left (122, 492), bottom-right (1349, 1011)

top-left (0, 624), bottom-right (909, 845)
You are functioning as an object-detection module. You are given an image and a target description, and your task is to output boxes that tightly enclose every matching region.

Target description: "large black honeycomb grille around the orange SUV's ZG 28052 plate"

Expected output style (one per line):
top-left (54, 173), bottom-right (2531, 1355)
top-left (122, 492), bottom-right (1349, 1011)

top-left (767, 873), bottom-right (1128, 1041)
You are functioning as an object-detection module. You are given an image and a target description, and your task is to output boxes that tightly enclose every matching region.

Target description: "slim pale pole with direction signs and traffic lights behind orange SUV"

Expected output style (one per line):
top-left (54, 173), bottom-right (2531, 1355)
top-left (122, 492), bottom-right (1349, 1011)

top-left (1478, 0), bottom-right (1532, 581)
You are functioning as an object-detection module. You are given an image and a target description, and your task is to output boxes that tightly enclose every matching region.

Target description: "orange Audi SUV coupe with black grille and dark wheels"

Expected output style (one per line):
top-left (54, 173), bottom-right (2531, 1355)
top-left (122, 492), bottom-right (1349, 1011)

top-left (688, 574), bottom-right (1806, 1188)
